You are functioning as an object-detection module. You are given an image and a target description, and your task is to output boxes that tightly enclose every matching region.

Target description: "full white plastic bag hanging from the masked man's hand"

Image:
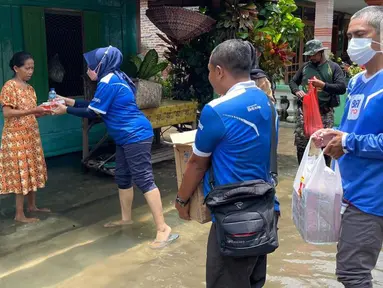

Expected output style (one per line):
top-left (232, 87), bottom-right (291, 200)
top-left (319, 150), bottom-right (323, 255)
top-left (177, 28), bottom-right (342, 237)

top-left (292, 139), bottom-right (343, 244)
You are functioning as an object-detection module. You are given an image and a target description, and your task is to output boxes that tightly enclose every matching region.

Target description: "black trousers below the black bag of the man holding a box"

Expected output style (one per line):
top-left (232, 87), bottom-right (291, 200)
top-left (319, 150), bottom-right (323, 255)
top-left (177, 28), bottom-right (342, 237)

top-left (206, 224), bottom-right (267, 288)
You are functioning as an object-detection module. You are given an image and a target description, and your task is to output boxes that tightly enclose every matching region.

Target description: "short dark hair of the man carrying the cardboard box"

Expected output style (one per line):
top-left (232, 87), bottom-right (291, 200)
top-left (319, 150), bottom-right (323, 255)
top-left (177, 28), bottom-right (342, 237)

top-left (210, 39), bottom-right (256, 76)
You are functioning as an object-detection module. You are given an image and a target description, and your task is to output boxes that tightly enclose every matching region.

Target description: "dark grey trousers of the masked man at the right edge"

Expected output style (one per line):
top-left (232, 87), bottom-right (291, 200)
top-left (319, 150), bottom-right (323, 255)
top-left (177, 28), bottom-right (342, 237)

top-left (336, 206), bottom-right (383, 288)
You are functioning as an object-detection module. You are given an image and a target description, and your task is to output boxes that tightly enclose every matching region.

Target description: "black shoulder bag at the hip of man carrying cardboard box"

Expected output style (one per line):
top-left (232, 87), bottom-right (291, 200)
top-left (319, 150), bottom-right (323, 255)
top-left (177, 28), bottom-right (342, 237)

top-left (205, 180), bottom-right (279, 257)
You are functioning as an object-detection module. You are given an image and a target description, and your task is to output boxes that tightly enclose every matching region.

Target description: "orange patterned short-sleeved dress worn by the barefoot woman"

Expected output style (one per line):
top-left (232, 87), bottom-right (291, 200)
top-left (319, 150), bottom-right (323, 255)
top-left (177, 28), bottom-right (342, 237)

top-left (0, 80), bottom-right (47, 195)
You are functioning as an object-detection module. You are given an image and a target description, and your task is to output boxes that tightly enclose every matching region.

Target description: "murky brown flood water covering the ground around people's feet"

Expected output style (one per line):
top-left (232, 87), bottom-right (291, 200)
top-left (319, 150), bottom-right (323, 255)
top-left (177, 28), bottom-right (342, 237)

top-left (0, 128), bottom-right (383, 288)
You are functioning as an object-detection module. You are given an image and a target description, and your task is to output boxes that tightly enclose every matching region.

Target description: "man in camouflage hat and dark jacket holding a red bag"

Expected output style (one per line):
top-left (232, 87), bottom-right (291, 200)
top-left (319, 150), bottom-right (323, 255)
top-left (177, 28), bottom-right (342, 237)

top-left (290, 40), bottom-right (346, 164)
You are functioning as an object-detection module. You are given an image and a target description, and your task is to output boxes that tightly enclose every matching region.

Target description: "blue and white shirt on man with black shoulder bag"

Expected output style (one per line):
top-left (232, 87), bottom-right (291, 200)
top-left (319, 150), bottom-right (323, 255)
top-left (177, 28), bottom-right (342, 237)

top-left (193, 81), bottom-right (276, 200)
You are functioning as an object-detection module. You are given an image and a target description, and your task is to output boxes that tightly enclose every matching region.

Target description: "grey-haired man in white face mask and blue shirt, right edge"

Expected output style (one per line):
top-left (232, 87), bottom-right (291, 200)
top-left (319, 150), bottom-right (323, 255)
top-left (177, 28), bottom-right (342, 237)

top-left (314, 6), bottom-right (383, 288)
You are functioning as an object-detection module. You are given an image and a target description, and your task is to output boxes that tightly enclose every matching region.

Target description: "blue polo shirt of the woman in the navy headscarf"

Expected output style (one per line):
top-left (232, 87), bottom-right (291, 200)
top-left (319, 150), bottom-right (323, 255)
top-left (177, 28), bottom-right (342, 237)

top-left (88, 73), bottom-right (153, 145)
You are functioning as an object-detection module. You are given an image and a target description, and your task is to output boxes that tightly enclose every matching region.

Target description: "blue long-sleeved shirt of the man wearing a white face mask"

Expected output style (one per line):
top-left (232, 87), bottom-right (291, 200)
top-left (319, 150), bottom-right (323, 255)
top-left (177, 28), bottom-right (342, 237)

top-left (339, 70), bottom-right (383, 216)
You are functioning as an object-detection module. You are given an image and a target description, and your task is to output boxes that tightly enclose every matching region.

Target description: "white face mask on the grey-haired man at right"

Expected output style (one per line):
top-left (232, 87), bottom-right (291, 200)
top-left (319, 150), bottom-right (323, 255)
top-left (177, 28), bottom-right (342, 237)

top-left (347, 38), bottom-right (382, 65)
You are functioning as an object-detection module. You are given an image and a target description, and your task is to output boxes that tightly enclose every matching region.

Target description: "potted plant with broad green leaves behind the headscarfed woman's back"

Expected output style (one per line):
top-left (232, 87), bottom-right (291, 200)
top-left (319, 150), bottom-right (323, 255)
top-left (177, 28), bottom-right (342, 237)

top-left (128, 49), bottom-right (168, 109)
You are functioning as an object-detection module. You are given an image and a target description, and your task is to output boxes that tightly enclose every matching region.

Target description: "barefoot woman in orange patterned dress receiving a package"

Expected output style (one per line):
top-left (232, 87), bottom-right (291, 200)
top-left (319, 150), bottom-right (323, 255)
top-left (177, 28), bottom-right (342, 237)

top-left (0, 52), bottom-right (50, 223)
